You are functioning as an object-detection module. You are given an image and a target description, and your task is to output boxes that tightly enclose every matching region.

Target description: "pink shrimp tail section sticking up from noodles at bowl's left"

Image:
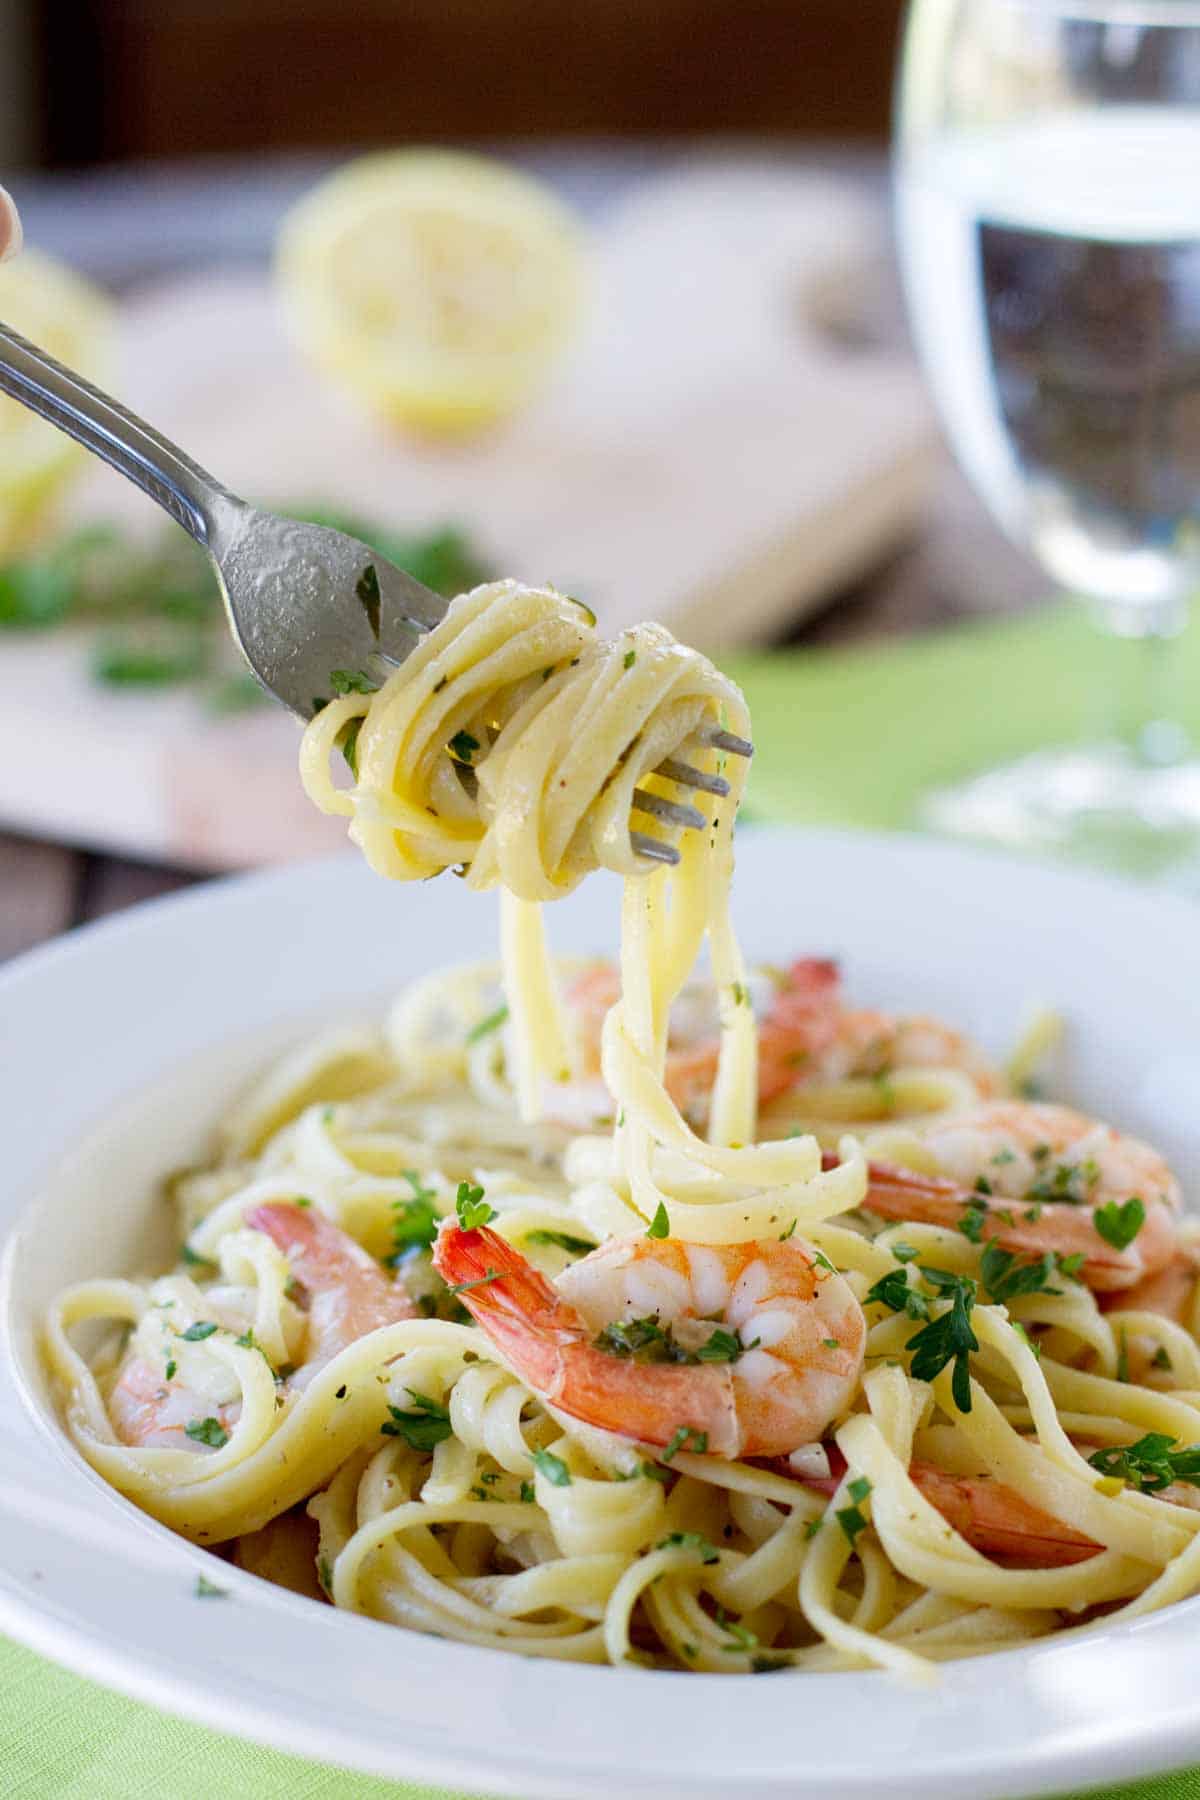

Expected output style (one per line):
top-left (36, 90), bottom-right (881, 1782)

top-left (246, 1201), bottom-right (416, 1388)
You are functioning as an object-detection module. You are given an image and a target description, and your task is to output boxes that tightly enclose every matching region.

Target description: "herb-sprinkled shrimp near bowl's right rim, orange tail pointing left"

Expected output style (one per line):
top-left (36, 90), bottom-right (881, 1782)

top-left (852, 1100), bottom-right (1182, 1292)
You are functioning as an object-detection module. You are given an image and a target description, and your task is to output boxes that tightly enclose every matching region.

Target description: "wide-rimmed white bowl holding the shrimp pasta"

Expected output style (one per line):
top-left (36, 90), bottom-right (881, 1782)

top-left (0, 832), bottom-right (1200, 1800)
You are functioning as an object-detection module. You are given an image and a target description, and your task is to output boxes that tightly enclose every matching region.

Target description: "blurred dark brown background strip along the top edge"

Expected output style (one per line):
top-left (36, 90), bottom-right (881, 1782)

top-left (35, 0), bottom-right (903, 167)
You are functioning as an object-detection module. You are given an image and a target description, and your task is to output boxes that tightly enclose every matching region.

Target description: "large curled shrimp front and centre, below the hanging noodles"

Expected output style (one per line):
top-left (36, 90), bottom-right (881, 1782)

top-left (434, 1222), bottom-right (865, 1458)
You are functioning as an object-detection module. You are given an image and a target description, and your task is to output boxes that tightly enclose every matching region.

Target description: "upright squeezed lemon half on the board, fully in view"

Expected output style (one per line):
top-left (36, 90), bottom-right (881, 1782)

top-left (275, 149), bottom-right (583, 434)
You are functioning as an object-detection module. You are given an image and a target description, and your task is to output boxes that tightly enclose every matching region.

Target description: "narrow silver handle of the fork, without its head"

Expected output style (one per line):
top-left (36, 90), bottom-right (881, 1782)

top-left (0, 324), bottom-right (243, 549)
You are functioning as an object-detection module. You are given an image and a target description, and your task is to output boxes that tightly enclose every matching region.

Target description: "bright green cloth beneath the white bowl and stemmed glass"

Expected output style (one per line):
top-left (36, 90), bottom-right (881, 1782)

top-left (9, 610), bottom-right (1200, 1800)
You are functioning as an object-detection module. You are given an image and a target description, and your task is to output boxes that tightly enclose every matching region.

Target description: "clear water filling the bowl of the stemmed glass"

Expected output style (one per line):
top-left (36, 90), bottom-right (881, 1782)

top-left (898, 106), bottom-right (1200, 630)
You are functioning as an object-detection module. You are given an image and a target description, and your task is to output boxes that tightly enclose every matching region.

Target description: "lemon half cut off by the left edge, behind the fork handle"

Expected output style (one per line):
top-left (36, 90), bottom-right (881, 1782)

top-left (0, 250), bottom-right (113, 554)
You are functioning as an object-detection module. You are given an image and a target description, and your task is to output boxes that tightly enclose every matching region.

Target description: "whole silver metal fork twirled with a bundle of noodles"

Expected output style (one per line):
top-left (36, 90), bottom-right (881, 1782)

top-left (0, 324), bottom-right (754, 862)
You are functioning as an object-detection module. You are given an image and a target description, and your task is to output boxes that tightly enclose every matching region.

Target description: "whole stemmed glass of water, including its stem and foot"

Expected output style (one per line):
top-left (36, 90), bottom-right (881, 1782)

top-left (894, 0), bottom-right (1200, 884)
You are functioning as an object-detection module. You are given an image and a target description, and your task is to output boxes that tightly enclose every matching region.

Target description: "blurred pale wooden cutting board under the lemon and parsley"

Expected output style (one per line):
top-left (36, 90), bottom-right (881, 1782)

top-left (0, 162), bottom-right (936, 868)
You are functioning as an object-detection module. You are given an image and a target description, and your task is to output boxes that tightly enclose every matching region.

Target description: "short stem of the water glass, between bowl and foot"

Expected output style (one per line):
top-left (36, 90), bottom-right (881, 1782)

top-left (1096, 598), bottom-right (1189, 769)
